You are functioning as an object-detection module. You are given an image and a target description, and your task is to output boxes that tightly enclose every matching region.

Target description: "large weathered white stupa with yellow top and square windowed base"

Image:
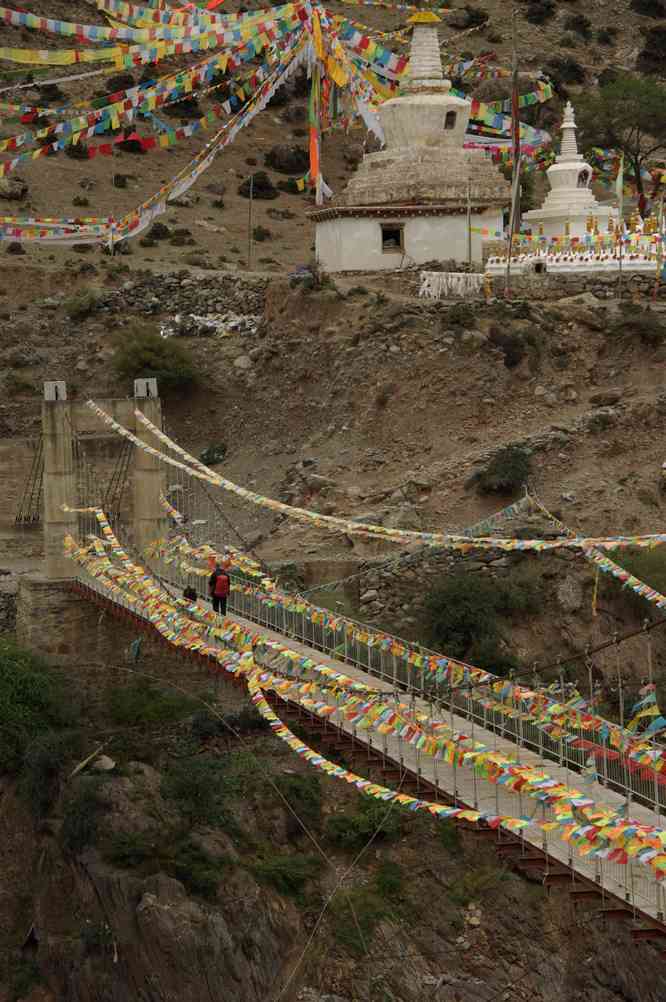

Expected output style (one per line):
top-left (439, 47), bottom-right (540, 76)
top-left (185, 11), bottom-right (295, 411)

top-left (310, 12), bottom-right (511, 272)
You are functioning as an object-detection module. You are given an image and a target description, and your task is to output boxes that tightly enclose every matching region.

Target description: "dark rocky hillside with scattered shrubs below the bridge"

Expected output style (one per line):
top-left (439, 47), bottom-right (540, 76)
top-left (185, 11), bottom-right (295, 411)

top-left (0, 648), bottom-right (666, 1002)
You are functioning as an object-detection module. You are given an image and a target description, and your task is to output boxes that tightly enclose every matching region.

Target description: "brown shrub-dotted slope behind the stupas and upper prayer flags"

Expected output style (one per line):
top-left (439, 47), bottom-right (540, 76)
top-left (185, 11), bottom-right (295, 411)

top-left (0, 0), bottom-right (664, 282)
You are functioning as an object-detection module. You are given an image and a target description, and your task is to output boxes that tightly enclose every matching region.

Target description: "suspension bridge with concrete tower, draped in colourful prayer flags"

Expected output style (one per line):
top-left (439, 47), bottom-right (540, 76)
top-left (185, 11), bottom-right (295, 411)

top-left (14, 381), bottom-right (666, 945)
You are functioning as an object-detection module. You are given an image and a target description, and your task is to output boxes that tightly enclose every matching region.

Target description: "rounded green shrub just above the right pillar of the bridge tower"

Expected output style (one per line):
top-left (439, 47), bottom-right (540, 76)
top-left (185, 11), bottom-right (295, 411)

top-left (113, 329), bottom-right (196, 393)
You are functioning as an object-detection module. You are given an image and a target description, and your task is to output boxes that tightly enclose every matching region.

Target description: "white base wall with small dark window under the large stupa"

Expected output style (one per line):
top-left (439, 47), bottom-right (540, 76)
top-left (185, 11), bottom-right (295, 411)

top-left (315, 209), bottom-right (502, 272)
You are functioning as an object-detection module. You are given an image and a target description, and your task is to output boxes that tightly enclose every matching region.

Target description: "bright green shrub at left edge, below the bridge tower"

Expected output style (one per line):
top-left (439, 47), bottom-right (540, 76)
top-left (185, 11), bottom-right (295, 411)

top-left (0, 639), bottom-right (77, 774)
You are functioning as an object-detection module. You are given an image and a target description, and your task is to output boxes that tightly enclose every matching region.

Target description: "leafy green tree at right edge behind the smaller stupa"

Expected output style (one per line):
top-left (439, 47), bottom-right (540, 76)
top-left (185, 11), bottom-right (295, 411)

top-left (576, 76), bottom-right (666, 194)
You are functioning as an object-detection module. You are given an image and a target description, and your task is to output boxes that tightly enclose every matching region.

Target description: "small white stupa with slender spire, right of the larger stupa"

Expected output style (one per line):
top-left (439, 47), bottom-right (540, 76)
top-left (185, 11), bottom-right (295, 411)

top-left (523, 101), bottom-right (618, 236)
